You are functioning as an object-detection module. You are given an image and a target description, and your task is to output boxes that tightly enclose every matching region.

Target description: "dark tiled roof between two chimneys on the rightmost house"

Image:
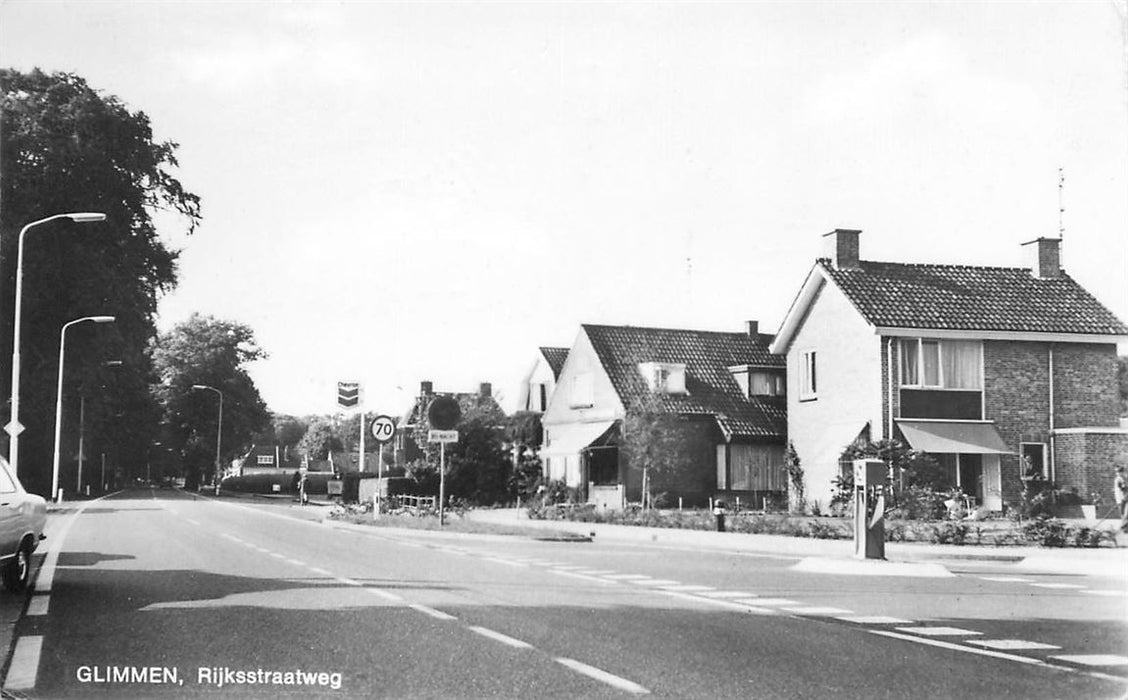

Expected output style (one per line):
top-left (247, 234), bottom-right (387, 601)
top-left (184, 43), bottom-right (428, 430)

top-left (818, 259), bottom-right (1128, 335)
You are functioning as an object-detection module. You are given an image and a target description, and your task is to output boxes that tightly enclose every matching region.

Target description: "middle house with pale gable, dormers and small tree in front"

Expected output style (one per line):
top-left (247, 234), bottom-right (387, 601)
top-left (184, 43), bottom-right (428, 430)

top-left (540, 322), bottom-right (786, 508)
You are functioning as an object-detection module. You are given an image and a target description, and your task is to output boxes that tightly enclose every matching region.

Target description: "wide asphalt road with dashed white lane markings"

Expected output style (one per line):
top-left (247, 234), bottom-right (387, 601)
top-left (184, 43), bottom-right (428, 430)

top-left (0, 490), bottom-right (1128, 699)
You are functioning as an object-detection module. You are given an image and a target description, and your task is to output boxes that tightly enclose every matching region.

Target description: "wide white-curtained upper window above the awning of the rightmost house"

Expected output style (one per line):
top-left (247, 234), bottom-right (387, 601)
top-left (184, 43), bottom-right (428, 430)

top-left (900, 338), bottom-right (982, 391)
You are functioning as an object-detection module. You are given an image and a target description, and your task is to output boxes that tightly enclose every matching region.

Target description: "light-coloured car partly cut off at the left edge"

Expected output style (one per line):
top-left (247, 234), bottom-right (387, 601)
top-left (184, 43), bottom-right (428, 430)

top-left (0, 457), bottom-right (47, 591)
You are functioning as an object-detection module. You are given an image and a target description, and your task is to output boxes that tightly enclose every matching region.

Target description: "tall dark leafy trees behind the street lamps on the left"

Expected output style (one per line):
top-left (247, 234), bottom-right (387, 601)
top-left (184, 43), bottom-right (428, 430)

top-left (0, 65), bottom-right (200, 493)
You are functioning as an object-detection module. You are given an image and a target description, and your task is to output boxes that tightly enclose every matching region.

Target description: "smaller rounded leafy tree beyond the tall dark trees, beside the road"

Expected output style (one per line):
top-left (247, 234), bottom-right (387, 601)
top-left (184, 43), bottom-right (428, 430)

top-left (151, 313), bottom-right (271, 487)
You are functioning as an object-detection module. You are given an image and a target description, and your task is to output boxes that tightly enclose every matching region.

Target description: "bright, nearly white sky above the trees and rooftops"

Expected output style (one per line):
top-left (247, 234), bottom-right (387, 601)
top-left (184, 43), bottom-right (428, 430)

top-left (0, 0), bottom-right (1128, 415)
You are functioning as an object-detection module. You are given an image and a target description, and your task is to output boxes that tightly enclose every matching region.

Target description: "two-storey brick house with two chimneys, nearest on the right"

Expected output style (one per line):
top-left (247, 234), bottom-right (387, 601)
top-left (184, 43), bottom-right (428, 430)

top-left (772, 229), bottom-right (1128, 511)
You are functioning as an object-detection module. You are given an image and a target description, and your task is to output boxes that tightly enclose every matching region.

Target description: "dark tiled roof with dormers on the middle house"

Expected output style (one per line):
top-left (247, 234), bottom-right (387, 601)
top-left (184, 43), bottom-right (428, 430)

top-left (583, 325), bottom-right (787, 438)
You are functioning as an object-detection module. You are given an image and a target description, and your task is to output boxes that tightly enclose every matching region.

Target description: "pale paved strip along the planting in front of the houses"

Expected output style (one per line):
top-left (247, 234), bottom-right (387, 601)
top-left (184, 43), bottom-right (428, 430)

top-left (465, 508), bottom-right (1128, 578)
